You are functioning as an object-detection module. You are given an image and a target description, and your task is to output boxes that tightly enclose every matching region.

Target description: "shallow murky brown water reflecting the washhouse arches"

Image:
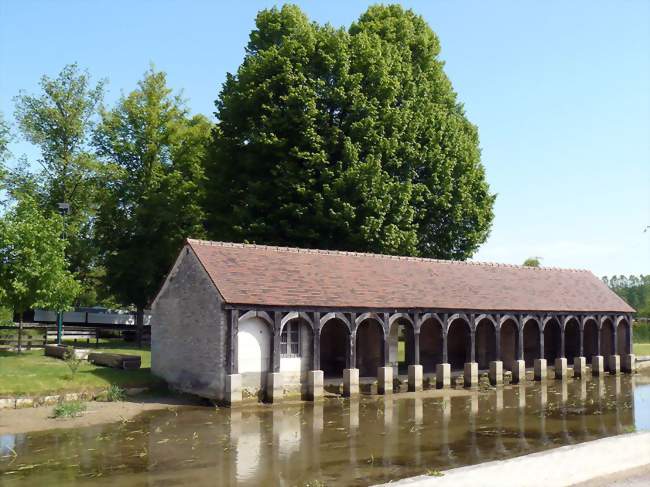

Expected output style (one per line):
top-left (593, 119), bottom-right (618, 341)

top-left (0, 372), bottom-right (650, 487)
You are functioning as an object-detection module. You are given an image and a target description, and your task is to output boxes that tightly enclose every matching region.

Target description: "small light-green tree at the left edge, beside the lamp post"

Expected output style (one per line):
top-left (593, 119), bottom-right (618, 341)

top-left (0, 195), bottom-right (80, 320)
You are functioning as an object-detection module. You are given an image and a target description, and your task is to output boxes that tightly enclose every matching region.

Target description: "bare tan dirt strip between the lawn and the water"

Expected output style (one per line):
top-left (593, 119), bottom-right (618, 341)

top-left (0, 396), bottom-right (203, 435)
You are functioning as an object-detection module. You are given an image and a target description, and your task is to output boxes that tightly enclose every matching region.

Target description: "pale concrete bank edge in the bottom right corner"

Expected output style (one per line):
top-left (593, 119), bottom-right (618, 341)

top-left (380, 432), bottom-right (650, 487)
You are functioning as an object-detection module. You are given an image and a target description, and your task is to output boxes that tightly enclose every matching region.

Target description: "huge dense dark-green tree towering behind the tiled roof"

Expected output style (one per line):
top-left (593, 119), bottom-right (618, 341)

top-left (206, 6), bottom-right (494, 259)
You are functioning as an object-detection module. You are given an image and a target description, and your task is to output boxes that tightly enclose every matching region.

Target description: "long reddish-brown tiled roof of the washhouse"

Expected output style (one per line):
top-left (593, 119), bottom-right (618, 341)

top-left (188, 240), bottom-right (634, 313)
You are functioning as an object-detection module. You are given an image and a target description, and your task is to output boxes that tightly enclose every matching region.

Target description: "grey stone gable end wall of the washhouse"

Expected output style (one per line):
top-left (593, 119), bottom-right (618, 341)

top-left (151, 247), bottom-right (227, 400)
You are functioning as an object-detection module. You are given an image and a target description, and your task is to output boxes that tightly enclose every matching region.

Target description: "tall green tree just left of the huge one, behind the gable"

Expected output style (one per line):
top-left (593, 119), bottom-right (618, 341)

top-left (94, 68), bottom-right (211, 344)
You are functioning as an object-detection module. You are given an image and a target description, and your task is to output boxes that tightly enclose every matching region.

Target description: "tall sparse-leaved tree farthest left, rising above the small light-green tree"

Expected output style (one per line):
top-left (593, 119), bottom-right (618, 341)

top-left (8, 64), bottom-right (104, 301)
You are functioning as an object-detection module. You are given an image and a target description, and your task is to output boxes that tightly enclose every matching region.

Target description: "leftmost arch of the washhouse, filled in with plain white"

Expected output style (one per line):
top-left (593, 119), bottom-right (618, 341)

top-left (237, 317), bottom-right (273, 391)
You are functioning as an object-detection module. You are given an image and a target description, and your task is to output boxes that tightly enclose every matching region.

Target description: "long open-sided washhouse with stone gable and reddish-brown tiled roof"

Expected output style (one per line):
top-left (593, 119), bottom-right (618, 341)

top-left (151, 240), bottom-right (635, 404)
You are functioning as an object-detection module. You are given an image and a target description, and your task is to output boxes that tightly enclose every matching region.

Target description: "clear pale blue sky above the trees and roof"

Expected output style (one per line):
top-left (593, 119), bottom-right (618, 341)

top-left (0, 0), bottom-right (650, 275)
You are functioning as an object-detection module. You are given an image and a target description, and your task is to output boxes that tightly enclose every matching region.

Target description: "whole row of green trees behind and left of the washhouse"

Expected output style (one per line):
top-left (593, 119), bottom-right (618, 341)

top-left (0, 6), bottom-right (494, 332)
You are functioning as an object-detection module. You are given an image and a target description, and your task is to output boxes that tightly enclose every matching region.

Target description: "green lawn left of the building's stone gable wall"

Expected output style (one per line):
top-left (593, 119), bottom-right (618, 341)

top-left (0, 341), bottom-right (160, 397)
